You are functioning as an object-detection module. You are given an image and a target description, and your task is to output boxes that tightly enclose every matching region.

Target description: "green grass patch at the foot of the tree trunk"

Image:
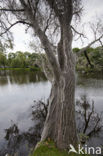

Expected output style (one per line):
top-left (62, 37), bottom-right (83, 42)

top-left (29, 141), bottom-right (89, 156)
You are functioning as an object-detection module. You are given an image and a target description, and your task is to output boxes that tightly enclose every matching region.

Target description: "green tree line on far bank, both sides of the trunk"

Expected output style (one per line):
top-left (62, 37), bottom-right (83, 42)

top-left (0, 47), bottom-right (103, 70)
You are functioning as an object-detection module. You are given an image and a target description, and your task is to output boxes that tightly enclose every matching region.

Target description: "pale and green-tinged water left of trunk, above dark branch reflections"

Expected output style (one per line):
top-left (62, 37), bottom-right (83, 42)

top-left (0, 71), bottom-right (50, 156)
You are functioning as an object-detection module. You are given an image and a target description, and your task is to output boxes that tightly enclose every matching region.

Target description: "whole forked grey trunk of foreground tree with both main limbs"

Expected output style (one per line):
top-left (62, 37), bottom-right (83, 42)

top-left (26, 1), bottom-right (78, 149)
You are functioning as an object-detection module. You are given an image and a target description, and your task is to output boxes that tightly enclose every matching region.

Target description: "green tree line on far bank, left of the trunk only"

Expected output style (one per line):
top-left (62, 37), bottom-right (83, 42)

top-left (0, 51), bottom-right (44, 68)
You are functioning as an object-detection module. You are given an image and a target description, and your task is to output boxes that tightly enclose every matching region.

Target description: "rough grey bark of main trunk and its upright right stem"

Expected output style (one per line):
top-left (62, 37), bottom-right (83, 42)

top-left (41, 26), bottom-right (78, 149)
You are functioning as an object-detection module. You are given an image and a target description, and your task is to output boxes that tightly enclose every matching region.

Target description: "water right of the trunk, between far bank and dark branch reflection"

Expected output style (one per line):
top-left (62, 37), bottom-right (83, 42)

top-left (76, 74), bottom-right (103, 112)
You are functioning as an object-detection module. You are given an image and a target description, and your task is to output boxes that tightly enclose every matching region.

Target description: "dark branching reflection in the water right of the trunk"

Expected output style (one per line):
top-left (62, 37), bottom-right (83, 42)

top-left (76, 95), bottom-right (103, 143)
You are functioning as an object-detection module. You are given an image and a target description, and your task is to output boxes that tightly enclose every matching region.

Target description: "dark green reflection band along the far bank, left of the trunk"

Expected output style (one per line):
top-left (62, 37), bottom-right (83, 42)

top-left (0, 70), bottom-right (46, 85)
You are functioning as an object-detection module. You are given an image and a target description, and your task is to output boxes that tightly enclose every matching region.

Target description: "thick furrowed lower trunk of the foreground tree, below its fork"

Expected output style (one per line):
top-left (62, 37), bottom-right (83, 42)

top-left (41, 70), bottom-right (78, 149)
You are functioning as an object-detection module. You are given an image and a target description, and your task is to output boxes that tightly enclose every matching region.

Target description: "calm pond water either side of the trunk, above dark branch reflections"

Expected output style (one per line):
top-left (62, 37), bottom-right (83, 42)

top-left (0, 71), bottom-right (103, 155)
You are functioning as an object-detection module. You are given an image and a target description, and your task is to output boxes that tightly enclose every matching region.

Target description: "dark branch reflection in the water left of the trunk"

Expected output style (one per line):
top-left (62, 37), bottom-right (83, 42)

top-left (0, 101), bottom-right (48, 156)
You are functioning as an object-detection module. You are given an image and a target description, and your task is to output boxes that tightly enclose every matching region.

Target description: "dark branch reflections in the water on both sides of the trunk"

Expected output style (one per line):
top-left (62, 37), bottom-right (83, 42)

top-left (2, 96), bottom-right (102, 156)
